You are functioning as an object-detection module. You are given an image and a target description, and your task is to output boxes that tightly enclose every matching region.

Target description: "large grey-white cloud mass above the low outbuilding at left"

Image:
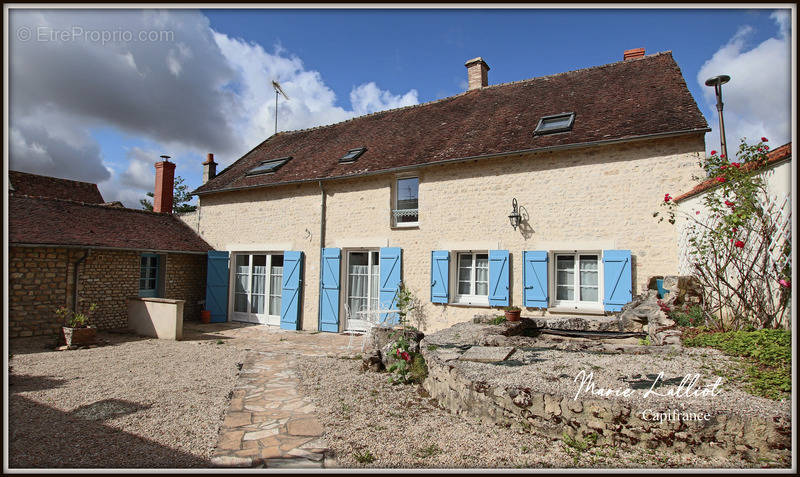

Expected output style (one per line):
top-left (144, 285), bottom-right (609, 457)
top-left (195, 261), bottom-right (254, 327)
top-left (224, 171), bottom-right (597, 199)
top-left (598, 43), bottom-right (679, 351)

top-left (9, 10), bottom-right (418, 207)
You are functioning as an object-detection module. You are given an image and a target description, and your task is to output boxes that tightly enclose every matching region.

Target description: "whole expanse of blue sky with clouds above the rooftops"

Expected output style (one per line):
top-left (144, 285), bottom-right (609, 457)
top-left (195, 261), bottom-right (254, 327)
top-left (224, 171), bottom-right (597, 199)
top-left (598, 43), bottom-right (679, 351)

top-left (9, 8), bottom-right (792, 206)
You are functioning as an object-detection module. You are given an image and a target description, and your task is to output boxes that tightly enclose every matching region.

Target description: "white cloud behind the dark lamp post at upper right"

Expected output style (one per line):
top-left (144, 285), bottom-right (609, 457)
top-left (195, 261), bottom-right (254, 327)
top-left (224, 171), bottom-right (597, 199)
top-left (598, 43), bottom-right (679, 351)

top-left (697, 10), bottom-right (791, 155)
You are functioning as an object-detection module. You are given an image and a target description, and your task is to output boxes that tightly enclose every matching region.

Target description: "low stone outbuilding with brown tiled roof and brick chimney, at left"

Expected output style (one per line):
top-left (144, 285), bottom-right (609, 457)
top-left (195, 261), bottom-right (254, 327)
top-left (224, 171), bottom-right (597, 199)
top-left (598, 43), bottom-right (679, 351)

top-left (8, 162), bottom-right (211, 338)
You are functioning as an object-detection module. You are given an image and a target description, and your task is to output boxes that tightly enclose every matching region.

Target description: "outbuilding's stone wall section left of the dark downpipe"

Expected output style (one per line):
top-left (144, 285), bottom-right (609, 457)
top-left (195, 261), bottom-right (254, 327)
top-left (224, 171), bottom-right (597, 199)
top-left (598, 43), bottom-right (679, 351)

top-left (8, 247), bottom-right (69, 338)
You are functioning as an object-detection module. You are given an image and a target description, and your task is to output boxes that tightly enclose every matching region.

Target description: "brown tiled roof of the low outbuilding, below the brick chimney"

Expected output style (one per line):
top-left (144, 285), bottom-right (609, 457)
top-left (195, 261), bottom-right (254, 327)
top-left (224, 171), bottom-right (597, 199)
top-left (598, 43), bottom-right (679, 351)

top-left (8, 194), bottom-right (212, 252)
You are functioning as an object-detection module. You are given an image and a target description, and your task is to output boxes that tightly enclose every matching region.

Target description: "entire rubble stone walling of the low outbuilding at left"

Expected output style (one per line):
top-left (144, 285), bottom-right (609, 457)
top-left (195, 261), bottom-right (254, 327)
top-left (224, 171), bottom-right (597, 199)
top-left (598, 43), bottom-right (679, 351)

top-left (9, 246), bottom-right (206, 338)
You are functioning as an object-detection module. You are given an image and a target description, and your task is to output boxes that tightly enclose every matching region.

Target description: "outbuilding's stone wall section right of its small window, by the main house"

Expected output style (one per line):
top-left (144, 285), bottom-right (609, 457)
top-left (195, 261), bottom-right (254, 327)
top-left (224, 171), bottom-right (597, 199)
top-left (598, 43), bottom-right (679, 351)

top-left (164, 253), bottom-right (208, 321)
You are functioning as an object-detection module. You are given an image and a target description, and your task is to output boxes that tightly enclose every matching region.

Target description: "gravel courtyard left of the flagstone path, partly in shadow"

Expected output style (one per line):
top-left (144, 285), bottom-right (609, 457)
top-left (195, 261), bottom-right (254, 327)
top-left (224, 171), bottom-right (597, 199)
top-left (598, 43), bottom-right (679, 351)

top-left (9, 326), bottom-right (245, 468)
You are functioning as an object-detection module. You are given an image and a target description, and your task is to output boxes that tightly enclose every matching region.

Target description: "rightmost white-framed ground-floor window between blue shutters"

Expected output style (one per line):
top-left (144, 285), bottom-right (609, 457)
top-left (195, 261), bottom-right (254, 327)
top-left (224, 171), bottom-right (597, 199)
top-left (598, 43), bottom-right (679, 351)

top-left (555, 252), bottom-right (601, 307)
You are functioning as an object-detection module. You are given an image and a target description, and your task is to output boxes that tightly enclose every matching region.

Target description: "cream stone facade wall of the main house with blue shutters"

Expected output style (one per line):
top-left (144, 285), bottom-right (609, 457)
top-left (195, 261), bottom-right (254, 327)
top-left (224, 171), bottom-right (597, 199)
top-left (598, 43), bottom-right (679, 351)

top-left (199, 135), bottom-right (705, 331)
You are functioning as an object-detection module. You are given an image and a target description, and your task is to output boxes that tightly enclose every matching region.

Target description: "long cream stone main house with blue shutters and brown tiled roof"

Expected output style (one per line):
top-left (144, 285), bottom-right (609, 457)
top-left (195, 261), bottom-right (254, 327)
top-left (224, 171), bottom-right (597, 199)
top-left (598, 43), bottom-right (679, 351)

top-left (191, 49), bottom-right (709, 332)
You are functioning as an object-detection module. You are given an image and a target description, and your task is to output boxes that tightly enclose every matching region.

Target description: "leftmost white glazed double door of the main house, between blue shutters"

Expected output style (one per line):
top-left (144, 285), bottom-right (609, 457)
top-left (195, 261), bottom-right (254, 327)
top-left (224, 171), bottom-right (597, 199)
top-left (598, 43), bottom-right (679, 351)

top-left (233, 253), bottom-right (283, 325)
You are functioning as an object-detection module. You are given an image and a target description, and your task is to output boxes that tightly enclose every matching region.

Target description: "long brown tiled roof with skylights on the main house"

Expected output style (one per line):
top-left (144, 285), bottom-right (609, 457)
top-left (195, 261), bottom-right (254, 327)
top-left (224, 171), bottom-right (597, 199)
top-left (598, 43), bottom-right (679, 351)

top-left (194, 52), bottom-right (708, 194)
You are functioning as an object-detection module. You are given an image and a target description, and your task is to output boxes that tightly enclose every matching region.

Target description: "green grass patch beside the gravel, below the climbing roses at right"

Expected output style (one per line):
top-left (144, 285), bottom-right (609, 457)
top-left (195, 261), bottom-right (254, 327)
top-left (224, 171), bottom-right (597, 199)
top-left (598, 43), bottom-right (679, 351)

top-left (683, 330), bottom-right (792, 399)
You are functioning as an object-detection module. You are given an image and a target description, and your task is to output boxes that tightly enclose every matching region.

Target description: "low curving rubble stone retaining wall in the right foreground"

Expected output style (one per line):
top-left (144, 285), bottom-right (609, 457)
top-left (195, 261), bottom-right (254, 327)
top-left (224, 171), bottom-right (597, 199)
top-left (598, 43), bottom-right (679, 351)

top-left (420, 324), bottom-right (791, 462)
